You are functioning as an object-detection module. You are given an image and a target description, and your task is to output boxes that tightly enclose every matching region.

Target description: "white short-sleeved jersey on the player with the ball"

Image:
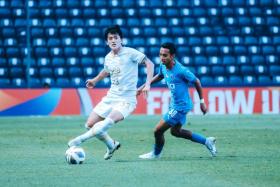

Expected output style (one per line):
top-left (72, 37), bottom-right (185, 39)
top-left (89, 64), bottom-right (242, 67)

top-left (104, 47), bottom-right (145, 102)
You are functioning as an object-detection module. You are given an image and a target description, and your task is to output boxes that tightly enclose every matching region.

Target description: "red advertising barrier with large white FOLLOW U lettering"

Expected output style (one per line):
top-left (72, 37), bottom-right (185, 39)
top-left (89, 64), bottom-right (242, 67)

top-left (0, 87), bottom-right (280, 116)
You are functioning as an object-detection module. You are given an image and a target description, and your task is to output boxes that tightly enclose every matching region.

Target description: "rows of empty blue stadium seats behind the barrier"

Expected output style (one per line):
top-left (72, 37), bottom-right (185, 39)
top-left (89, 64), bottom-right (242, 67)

top-left (0, 0), bottom-right (280, 88)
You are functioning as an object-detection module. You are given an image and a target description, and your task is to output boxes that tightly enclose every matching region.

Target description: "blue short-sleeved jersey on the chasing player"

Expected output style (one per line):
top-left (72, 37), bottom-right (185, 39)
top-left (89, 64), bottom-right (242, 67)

top-left (159, 61), bottom-right (197, 112)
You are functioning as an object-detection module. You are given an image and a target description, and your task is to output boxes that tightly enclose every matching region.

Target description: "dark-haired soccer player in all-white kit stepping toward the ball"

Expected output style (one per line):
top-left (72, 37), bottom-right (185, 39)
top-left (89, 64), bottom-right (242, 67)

top-left (68, 25), bottom-right (154, 160)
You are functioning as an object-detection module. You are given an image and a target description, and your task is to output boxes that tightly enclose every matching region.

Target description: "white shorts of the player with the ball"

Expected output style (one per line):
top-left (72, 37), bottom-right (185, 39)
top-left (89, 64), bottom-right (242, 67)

top-left (93, 97), bottom-right (136, 118)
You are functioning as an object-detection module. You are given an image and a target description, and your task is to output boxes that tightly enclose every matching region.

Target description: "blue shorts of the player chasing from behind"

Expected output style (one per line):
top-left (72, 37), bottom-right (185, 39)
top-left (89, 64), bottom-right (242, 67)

top-left (163, 109), bottom-right (187, 127)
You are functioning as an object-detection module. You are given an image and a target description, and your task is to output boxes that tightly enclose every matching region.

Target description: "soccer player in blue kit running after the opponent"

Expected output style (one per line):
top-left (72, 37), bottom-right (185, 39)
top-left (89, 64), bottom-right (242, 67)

top-left (138, 43), bottom-right (217, 159)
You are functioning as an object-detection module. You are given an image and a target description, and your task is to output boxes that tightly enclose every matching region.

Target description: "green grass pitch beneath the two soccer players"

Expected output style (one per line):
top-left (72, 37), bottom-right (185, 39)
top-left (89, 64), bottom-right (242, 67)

top-left (0, 115), bottom-right (280, 187)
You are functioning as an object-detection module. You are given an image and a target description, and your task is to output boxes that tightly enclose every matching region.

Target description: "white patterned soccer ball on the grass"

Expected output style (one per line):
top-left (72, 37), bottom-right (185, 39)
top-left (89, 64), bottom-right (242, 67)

top-left (65, 147), bottom-right (86, 164)
